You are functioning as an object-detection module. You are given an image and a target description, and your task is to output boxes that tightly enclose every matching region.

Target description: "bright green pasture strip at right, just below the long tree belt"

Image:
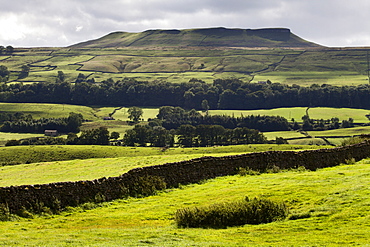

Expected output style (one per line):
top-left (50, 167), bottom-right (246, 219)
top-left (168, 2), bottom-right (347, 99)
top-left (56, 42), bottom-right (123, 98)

top-left (209, 107), bottom-right (370, 123)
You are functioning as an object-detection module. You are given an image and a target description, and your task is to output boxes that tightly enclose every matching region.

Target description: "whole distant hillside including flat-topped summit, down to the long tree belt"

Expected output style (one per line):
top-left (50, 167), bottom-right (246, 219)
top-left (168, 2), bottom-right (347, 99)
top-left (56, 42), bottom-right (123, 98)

top-left (0, 28), bottom-right (368, 85)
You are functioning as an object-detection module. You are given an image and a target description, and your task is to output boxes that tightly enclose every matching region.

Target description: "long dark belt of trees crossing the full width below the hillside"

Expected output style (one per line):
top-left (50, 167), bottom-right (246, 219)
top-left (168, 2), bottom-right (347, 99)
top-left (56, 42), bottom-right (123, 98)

top-left (0, 77), bottom-right (370, 110)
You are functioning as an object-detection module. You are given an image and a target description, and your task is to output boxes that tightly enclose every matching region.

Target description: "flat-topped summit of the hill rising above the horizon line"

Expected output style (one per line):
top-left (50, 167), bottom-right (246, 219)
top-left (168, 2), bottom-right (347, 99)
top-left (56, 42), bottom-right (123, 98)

top-left (71, 27), bottom-right (320, 48)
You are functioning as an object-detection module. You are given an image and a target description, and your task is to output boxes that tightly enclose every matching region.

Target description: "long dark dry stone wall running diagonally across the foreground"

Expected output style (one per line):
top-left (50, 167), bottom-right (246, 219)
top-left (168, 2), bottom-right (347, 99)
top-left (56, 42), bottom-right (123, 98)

top-left (0, 141), bottom-right (370, 213)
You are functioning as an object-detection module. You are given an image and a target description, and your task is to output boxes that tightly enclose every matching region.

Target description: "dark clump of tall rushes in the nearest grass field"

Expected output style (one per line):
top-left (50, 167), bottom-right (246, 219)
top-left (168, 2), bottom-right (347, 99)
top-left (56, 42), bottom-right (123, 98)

top-left (175, 197), bottom-right (288, 228)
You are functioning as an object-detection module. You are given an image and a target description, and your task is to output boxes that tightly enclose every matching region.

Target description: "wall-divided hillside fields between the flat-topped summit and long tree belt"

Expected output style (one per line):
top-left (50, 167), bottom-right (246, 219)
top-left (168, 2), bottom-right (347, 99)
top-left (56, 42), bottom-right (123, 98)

top-left (5, 47), bottom-right (368, 86)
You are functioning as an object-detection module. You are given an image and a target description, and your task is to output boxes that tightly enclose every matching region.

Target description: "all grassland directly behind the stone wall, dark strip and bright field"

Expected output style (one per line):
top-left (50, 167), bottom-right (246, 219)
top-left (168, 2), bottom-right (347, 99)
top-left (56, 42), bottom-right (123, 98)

top-left (0, 144), bottom-right (319, 187)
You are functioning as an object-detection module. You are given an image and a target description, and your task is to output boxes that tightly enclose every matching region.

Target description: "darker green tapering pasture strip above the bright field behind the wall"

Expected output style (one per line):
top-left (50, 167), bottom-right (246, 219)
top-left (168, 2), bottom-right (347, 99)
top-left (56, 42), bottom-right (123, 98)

top-left (0, 144), bottom-right (319, 171)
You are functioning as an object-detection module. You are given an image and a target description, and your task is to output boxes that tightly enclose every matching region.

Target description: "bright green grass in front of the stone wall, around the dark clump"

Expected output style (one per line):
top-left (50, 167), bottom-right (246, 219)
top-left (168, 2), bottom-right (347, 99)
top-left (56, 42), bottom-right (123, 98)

top-left (0, 159), bottom-right (370, 246)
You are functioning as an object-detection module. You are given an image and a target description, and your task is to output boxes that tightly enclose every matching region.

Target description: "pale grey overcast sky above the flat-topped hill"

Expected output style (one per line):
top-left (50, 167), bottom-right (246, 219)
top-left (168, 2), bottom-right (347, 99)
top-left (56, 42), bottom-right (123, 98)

top-left (0, 0), bottom-right (370, 47)
